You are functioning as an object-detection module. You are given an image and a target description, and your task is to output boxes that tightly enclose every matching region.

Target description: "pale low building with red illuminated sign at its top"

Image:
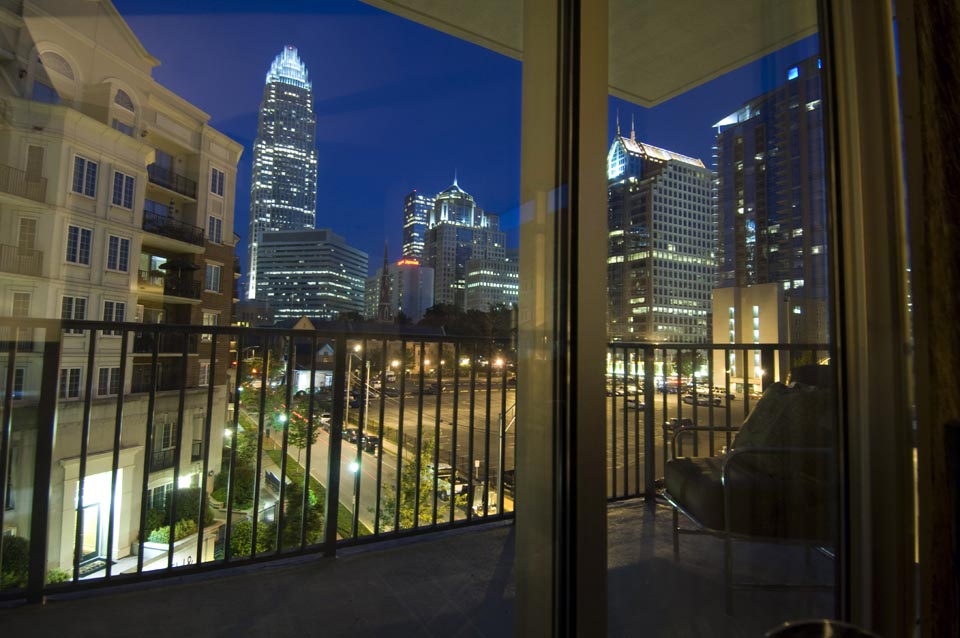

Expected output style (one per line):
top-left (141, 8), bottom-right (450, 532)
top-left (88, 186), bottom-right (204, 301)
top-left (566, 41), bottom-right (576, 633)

top-left (364, 258), bottom-right (434, 323)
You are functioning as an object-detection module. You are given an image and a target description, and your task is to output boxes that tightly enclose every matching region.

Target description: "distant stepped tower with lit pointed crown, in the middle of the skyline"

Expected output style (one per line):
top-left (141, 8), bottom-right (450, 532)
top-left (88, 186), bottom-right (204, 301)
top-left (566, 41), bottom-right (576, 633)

top-left (424, 179), bottom-right (506, 308)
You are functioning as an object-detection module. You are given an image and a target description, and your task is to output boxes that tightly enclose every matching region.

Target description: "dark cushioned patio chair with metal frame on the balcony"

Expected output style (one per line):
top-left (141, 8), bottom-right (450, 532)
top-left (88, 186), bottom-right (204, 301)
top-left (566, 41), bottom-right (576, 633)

top-left (663, 366), bottom-right (836, 613)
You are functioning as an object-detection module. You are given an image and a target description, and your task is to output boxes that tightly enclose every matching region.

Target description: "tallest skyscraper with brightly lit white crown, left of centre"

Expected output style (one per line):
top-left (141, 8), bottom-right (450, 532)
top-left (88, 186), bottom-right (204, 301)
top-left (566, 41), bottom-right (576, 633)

top-left (247, 46), bottom-right (317, 300)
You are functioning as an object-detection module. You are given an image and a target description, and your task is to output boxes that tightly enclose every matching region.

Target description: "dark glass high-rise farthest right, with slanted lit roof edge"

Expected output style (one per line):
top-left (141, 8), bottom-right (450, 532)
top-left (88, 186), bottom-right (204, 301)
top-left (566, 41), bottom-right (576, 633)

top-left (714, 57), bottom-right (827, 350)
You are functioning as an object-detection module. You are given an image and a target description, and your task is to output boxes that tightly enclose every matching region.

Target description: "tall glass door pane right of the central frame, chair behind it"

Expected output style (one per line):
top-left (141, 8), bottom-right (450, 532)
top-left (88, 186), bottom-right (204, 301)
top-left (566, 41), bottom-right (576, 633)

top-left (606, 3), bottom-right (838, 636)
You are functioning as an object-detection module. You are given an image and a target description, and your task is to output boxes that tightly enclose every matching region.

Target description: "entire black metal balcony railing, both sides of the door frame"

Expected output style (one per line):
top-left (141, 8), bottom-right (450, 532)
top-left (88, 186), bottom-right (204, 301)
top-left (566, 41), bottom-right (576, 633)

top-left (0, 318), bottom-right (826, 600)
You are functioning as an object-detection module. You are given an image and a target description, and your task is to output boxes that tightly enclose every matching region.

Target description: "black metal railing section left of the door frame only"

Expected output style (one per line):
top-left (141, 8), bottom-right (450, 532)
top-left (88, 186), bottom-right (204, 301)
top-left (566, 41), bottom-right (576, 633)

top-left (0, 318), bottom-right (517, 601)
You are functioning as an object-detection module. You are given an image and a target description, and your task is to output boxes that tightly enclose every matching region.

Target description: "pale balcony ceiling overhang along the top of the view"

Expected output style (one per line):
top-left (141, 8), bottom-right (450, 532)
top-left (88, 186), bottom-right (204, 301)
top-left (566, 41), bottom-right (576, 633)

top-left (363, 0), bottom-right (817, 107)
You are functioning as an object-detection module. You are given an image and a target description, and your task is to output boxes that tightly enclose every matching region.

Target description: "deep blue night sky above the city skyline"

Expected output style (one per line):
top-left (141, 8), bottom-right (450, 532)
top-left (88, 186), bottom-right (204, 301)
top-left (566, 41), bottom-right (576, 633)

top-left (114, 0), bottom-right (817, 272)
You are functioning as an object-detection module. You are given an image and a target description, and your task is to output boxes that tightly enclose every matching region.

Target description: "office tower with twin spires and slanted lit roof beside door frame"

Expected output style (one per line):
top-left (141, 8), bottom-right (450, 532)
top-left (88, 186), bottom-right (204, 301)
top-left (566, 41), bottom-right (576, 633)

top-left (607, 125), bottom-right (716, 343)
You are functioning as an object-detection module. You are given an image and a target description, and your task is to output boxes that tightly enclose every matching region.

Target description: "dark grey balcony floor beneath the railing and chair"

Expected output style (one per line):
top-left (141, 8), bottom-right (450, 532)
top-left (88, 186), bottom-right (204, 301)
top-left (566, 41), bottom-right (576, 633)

top-left (0, 501), bottom-right (832, 638)
